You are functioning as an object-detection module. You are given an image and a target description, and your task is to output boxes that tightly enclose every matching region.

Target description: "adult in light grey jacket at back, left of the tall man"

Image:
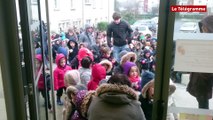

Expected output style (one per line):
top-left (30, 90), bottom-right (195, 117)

top-left (79, 24), bottom-right (95, 49)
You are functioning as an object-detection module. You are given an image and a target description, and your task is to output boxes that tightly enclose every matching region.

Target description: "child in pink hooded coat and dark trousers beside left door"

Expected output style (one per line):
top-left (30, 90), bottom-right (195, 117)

top-left (53, 54), bottom-right (72, 105)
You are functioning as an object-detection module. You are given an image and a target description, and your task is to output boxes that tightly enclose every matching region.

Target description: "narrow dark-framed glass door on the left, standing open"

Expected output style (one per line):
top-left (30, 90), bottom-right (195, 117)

top-left (18, 0), bottom-right (55, 120)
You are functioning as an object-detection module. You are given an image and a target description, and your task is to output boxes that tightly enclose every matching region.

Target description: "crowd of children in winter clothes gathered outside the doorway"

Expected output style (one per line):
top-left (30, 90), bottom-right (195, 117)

top-left (34, 26), bottom-right (176, 120)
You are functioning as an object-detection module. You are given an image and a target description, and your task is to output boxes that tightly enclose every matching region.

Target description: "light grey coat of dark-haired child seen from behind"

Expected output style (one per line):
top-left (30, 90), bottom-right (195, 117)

top-left (79, 68), bottom-right (92, 86)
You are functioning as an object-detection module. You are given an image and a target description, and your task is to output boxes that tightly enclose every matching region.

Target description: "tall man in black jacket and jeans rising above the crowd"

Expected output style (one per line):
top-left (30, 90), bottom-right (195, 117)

top-left (107, 12), bottom-right (133, 62)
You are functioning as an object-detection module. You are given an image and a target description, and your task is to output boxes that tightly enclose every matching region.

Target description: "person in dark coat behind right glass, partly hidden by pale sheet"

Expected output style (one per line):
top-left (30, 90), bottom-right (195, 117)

top-left (187, 15), bottom-right (213, 109)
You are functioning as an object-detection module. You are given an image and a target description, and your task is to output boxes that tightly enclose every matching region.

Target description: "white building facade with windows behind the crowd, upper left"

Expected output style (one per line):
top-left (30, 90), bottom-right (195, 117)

top-left (37, 0), bottom-right (114, 32)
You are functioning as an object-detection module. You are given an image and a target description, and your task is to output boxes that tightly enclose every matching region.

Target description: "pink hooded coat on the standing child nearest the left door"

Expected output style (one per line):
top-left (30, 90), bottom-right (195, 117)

top-left (53, 54), bottom-right (72, 90)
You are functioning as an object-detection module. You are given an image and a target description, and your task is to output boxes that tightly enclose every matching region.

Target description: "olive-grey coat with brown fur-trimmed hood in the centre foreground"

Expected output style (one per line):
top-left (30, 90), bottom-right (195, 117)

top-left (87, 84), bottom-right (145, 120)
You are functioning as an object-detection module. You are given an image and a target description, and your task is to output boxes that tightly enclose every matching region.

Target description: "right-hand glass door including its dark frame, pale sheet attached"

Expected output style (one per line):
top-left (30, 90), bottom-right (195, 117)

top-left (153, 0), bottom-right (213, 120)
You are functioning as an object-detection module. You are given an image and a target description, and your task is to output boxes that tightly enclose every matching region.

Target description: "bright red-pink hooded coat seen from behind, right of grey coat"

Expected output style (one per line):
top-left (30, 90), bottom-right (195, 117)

top-left (87, 64), bottom-right (106, 90)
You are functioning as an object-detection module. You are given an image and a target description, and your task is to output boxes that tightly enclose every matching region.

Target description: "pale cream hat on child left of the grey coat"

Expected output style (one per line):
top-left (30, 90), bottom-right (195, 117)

top-left (64, 70), bottom-right (80, 86)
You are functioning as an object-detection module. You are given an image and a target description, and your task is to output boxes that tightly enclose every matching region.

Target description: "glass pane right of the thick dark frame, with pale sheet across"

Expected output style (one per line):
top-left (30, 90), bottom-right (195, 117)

top-left (168, 1), bottom-right (213, 120)
